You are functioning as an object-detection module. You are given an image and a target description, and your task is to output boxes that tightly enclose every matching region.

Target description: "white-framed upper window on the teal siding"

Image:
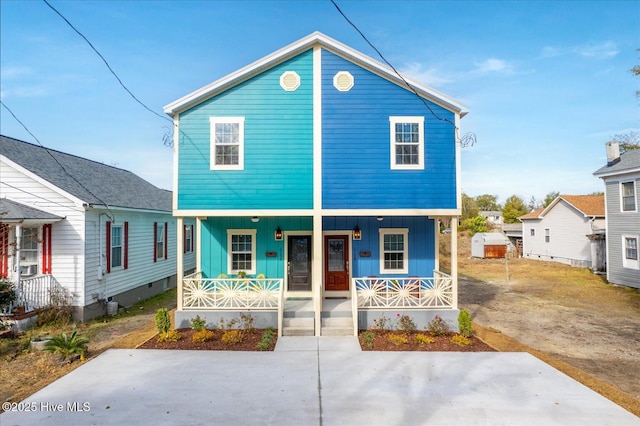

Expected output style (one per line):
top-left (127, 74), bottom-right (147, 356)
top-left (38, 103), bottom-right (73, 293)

top-left (209, 117), bottom-right (244, 170)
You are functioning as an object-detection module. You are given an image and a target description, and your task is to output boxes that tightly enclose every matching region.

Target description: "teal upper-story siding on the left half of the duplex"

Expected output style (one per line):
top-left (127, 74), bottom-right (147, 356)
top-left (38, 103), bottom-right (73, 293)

top-left (177, 50), bottom-right (313, 210)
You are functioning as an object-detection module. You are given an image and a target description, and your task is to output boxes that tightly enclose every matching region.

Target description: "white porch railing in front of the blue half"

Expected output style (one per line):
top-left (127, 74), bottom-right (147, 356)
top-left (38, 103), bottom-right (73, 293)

top-left (353, 271), bottom-right (454, 309)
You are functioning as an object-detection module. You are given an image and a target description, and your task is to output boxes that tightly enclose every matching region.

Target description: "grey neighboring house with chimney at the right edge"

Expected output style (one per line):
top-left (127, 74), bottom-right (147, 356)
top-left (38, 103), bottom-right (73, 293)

top-left (593, 142), bottom-right (640, 288)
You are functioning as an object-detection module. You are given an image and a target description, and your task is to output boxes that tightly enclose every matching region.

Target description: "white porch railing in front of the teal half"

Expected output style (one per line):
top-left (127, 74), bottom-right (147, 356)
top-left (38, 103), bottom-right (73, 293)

top-left (182, 272), bottom-right (283, 310)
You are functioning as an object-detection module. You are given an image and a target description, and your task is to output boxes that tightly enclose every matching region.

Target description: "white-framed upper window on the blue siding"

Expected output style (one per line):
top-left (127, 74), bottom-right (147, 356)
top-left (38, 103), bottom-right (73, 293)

top-left (389, 117), bottom-right (424, 170)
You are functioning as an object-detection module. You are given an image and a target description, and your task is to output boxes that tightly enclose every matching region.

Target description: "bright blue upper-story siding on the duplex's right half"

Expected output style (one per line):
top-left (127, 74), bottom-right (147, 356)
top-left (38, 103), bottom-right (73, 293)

top-left (322, 50), bottom-right (457, 209)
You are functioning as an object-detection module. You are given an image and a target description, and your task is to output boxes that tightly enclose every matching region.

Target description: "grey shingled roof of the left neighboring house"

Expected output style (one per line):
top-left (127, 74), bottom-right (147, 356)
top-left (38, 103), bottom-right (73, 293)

top-left (0, 135), bottom-right (172, 211)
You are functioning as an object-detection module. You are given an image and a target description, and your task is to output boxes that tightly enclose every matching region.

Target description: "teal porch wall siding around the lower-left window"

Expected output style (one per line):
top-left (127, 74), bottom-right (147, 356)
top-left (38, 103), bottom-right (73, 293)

top-left (200, 217), bottom-right (313, 278)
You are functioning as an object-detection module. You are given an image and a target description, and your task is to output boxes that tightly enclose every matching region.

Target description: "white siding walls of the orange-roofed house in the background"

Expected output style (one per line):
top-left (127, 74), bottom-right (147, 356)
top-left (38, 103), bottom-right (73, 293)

top-left (522, 200), bottom-right (603, 267)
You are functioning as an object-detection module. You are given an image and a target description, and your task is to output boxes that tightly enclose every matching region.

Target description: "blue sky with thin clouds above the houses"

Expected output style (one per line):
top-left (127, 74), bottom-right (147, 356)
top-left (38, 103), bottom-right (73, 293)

top-left (0, 0), bottom-right (640, 203)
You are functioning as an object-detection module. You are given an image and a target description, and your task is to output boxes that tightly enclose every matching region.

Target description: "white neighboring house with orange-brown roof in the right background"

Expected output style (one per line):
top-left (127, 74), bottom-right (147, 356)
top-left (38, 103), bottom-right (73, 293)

top-left (519, 195), bottom-right (605, 270)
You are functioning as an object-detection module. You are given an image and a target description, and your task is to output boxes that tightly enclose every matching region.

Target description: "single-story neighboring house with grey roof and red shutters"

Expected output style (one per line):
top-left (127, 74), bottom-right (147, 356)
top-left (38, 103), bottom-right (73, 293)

top-left (0, 136), bottom-right (195, 320)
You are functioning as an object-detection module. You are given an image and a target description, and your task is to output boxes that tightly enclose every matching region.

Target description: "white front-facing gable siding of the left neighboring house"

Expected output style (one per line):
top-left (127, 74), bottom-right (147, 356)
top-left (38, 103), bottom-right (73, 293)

top-left (0, 161), bottom-right (85, 306)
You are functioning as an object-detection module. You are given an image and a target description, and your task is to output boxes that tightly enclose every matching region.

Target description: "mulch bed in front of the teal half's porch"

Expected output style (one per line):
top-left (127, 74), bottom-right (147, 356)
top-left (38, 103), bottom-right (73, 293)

top-left (138, 328), bottom-right (277, 351)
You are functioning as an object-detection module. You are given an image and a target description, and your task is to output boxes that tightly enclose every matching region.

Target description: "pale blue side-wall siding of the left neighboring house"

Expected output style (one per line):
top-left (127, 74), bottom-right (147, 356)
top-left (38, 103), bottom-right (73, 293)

top-left (85, 209), bottom-right (180, 305)
